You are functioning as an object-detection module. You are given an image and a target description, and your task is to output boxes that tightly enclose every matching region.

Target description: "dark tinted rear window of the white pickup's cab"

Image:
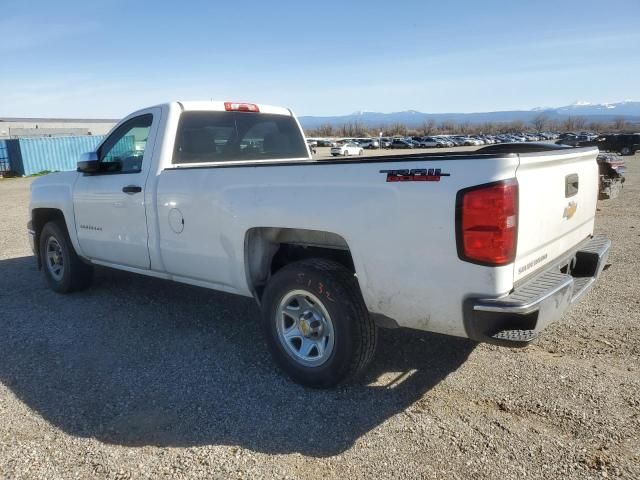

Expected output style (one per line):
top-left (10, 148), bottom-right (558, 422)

top-left (173, 112), bottom-right (308, 164)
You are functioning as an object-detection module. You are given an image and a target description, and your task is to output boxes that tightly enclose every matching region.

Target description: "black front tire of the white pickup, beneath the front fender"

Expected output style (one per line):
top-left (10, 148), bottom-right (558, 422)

top-left (39, 221), bottom-right (93, 293)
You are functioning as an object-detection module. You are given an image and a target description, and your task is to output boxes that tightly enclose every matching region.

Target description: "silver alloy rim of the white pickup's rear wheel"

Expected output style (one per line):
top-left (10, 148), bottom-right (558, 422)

top-left (276, 290), bottom-right (335, 367)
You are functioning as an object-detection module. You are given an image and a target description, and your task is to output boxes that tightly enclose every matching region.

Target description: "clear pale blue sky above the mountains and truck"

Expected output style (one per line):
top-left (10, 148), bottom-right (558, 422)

top-left (0, 0), bottom-right (640, 118)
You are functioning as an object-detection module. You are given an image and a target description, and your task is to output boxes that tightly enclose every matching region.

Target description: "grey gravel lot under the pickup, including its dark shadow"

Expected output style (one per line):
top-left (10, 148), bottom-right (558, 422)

top-left (0, 149), bottom-right (640, 480)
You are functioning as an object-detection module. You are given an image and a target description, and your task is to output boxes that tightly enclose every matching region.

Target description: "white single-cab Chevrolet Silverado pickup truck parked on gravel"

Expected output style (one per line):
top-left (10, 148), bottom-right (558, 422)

top-left (28, 102), bottom-right (610, 387)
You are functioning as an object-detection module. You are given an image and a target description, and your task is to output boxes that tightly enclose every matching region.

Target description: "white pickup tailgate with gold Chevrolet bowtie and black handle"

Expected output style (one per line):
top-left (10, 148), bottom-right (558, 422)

top-left (513, 148), bottom-right (598, 283)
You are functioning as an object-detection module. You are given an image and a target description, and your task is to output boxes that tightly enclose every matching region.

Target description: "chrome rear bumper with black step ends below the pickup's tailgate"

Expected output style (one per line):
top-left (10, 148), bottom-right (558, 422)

top-left (464, 236), bottom-right (611, 347)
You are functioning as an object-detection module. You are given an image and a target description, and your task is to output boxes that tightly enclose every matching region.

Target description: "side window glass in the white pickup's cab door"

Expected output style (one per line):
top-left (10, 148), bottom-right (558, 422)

top-left (98, 113), bottom-right (153, 173)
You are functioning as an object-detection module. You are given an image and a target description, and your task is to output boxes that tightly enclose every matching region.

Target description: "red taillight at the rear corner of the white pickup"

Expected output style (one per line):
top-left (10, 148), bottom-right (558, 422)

top-left (456, 178), bottom-right (518, 266)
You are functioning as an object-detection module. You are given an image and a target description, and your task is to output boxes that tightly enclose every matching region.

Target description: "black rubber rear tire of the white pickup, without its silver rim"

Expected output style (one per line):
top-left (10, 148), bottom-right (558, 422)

top-left (262, 259), bottom-right (378, 388)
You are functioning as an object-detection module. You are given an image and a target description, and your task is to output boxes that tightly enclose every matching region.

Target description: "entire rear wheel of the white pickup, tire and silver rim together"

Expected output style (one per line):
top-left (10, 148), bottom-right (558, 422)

top-left (262, 259), bottom-right (377, 387)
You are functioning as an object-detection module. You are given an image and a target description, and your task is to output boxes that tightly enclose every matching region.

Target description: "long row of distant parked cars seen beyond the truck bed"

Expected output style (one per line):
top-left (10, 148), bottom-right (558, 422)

top-left (307, 132), bottom-right (559, 156)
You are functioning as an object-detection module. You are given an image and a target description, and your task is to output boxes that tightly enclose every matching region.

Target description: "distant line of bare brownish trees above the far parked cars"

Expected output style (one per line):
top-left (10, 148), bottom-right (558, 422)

top-left (305, 114), bottom-right (640, 137)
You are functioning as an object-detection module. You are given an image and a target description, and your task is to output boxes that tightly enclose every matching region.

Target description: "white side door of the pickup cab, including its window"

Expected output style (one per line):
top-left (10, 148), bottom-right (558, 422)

top-left (73, 107), bottom-right (161, 269)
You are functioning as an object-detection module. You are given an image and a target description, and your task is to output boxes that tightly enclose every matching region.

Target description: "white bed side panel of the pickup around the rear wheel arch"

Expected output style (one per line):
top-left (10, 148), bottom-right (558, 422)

top-left (156, 156), bottom-right (518, 336)
